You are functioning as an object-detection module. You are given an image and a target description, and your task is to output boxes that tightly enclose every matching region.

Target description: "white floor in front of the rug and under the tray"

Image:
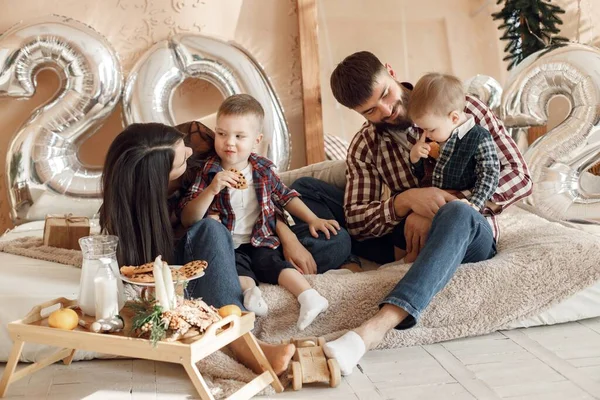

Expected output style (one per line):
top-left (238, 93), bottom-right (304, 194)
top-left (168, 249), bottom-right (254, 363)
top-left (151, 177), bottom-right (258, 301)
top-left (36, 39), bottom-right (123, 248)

top-left (0, 318), bottom-right (600, 400)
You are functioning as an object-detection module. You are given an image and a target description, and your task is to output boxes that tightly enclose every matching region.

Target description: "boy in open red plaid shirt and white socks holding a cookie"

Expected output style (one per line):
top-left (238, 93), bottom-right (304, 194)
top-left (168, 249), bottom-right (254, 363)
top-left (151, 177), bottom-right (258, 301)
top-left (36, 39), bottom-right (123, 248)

top-left (181, 94), bottom-right (340, 330)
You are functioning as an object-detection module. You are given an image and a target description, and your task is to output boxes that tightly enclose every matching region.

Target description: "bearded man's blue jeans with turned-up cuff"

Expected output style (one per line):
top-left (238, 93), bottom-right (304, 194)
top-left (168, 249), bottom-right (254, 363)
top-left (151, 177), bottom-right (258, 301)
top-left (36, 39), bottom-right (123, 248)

top-left (292, 177), bottom-right (496, 329)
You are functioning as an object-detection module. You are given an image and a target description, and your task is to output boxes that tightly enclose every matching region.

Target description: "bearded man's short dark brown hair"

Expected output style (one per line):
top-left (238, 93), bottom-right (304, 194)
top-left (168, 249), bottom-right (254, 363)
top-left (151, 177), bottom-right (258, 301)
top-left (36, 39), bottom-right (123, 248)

top-left (330, 51), bottom-right (385, 108)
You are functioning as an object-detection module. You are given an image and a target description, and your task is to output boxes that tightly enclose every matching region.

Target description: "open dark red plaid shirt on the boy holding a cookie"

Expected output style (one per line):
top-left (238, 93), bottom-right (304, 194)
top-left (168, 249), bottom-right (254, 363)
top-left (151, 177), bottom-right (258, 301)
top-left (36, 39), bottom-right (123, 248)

top-left (179, 153), bottom-right (300, 249)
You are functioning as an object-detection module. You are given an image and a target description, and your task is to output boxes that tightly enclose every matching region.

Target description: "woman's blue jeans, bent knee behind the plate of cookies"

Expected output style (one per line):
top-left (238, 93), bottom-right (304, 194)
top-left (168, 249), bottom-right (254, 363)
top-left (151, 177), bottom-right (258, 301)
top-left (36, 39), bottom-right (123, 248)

top-left (177, 218), bottom-right (244, 310)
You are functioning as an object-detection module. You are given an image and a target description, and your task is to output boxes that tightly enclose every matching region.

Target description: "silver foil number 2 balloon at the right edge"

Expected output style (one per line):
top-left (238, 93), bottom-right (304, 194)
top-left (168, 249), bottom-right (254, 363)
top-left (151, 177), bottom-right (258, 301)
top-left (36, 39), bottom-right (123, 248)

top-left (501, 44), bottom-right (600, 221)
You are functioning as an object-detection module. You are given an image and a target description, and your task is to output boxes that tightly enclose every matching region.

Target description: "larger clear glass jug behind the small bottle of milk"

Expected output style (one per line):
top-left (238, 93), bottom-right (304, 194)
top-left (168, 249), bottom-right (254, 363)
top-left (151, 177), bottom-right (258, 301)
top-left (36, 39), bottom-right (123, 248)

top-left (77, 235), bottom-right (125, 317)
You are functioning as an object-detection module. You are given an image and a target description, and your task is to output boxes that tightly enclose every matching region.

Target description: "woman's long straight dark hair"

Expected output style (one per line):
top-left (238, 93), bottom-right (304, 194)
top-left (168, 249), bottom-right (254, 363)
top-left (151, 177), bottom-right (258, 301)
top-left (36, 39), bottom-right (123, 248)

top-left (100, 123), bottom-right (183, 265)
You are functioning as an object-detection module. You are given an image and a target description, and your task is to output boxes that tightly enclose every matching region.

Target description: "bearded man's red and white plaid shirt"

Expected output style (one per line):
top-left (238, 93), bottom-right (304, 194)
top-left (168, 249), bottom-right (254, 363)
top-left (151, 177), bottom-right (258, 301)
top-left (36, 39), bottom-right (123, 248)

top-left (344, 96), bottom-right (532, 240)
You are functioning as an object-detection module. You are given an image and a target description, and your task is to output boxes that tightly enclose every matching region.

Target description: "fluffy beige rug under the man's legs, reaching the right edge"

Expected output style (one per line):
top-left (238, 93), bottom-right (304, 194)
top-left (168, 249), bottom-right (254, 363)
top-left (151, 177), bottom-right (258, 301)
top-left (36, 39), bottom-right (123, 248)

top-left (200, 207), bottom-right (600, 397)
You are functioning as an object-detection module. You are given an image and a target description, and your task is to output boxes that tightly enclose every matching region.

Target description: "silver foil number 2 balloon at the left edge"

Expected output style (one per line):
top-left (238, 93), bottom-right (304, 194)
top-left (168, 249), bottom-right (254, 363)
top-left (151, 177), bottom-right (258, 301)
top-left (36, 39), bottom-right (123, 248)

top-left (0, 16), bottom-right (123, 223)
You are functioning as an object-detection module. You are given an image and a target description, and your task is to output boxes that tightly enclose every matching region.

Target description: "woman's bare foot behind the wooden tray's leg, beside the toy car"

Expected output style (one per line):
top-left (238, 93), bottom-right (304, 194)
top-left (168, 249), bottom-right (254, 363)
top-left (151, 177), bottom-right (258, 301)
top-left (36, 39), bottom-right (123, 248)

top-left (229, 339), bottom-right (296, 375)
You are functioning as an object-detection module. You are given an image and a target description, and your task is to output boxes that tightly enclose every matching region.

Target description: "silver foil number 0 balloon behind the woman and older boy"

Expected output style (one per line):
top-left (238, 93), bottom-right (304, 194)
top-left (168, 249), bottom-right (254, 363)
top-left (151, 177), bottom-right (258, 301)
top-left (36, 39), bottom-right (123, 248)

top-left (123, 35), bottom-right (290, 171)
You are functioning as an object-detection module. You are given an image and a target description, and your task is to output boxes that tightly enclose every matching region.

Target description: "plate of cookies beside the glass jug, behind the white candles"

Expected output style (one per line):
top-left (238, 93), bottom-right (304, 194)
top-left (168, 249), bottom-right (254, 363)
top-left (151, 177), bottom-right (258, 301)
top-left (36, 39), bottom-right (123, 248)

top-left (120, 260), bottom-right (208, 287)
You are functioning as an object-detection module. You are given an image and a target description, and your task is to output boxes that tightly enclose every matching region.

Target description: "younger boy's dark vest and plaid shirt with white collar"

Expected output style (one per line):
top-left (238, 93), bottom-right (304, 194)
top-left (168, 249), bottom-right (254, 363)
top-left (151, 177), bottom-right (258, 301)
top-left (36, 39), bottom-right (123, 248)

top-left (411, 117), bottom-right (500, 210)
